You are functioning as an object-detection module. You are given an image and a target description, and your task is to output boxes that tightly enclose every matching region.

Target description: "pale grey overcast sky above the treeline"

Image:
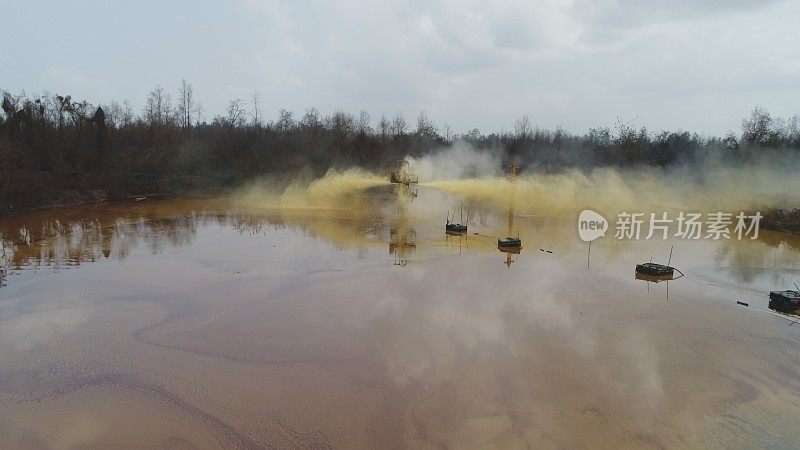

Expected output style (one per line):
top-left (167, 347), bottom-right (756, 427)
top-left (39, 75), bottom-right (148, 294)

top-left (0, 0), bottom-right (800, 135)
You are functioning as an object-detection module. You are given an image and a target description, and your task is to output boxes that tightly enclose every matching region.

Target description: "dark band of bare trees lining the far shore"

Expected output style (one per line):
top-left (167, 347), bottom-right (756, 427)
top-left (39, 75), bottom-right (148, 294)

top-left (0, 80), bottom-right (800, 215)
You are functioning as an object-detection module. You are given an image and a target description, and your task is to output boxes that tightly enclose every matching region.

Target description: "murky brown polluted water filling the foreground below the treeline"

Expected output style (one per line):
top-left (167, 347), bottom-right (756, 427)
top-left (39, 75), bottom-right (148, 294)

top-left (0, 192), bottom-right (800, 448)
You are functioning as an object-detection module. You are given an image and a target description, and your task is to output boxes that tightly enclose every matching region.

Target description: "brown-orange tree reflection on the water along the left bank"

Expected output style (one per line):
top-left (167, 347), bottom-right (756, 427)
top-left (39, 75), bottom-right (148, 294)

top-left (0, 200), bottom-right (396, 282)
